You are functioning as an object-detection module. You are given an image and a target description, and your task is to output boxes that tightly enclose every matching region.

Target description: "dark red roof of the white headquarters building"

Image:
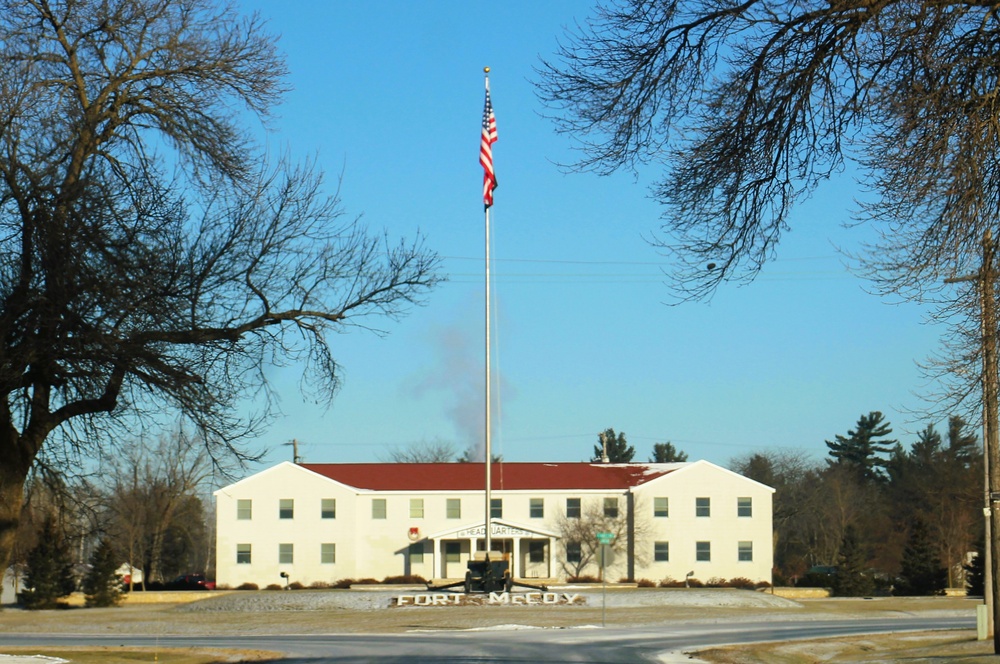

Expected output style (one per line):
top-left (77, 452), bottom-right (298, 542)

top-left (299, 462), bottom-right (679, 491)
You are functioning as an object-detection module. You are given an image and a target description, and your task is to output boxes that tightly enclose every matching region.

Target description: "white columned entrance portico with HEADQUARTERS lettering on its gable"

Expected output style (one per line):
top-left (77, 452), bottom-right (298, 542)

top-left (427, 519), bottom-right (559, 579)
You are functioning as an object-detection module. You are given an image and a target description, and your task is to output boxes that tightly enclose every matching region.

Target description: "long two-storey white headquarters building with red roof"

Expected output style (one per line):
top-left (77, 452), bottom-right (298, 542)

top-left (215, 461), bottom-right (774, 587)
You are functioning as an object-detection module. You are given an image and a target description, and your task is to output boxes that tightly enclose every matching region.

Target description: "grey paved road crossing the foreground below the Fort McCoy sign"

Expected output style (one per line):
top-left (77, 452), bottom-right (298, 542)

top-left (0, 617), bottom-right (975, 664)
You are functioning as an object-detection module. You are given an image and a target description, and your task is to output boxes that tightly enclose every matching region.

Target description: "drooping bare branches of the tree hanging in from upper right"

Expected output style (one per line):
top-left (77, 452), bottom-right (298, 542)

top-left (538, 0), bottom-right (1000, 298)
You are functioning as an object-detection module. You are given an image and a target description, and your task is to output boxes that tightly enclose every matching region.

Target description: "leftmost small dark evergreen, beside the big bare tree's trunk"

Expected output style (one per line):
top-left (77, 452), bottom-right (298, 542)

top-left (18, 517), bottom-right (76, 609)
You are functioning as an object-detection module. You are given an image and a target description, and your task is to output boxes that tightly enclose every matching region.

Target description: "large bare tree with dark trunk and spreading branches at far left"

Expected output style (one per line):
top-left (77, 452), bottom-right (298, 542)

top-left (0, 0), bottom-right (438, 567)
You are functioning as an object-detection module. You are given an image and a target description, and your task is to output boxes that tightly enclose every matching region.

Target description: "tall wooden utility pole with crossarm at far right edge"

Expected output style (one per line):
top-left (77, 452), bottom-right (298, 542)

top-left (945, 229), bottom-right (1000, 654)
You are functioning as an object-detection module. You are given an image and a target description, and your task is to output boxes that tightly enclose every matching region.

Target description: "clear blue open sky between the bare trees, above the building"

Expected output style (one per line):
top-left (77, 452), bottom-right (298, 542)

top-left (238, 0), bottom-right (942, 465)
